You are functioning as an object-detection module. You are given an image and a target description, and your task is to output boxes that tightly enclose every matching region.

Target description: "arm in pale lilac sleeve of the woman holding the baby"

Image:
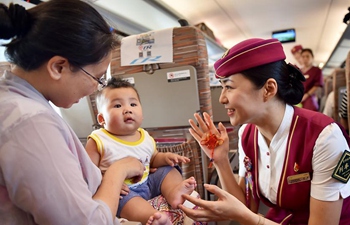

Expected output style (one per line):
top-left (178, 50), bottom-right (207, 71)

top-left (0, 114), bottom-right (143, 225)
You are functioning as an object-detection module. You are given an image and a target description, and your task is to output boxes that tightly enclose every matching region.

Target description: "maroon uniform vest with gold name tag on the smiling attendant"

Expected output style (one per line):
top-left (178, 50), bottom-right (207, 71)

top-left (242, 107), bottom-right (350, 225)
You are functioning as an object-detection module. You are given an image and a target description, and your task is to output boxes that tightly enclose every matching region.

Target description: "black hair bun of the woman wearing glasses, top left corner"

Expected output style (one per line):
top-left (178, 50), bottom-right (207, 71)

top-left (0, 3), bottom-right (30, 40)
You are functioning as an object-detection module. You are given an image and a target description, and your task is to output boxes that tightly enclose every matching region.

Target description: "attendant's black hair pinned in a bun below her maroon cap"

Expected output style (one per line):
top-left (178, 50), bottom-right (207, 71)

top-left (241, 60), bottom-right (305, 105)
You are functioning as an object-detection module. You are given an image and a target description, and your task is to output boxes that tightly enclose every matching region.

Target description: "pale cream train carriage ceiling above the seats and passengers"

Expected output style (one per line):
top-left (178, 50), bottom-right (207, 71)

top-left (0, 0), bottom-right (350, 72)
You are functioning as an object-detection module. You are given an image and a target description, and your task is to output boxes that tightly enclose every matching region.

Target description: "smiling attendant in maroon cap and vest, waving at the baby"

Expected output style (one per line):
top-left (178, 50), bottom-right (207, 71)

top-left (179, 38), bottom-right (350, 225)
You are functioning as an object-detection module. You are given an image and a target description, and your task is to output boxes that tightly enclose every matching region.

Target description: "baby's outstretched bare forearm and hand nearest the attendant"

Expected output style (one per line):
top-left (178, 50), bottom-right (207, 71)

top-left (151, 151), bottom-right (191, 168)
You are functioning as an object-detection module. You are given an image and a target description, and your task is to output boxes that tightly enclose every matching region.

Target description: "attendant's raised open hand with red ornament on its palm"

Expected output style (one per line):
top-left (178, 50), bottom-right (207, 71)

top-left (189, 113), bottom-right (229, 163)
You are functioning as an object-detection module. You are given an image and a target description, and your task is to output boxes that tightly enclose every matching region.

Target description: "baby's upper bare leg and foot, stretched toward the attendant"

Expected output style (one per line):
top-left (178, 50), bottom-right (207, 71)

top-left (161, 169), bottom-right (197, 209)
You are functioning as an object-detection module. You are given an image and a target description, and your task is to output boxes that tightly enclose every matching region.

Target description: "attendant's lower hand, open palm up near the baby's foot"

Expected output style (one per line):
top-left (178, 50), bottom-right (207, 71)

top-left (179, 184), bottom-right (250, 221)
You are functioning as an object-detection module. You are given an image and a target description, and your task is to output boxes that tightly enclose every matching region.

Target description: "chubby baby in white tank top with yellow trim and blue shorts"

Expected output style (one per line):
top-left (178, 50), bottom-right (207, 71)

top-left (86, 77), bottom-right (196, 225)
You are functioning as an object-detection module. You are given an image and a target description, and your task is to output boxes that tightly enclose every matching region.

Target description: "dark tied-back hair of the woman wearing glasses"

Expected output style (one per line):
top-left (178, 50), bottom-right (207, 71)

top-left (0, 0), bottom-right (118, 71)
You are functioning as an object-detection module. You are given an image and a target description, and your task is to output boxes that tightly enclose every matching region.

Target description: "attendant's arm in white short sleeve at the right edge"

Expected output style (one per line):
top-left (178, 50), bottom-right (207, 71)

top-left (309, 123), bottom-right (350, 225)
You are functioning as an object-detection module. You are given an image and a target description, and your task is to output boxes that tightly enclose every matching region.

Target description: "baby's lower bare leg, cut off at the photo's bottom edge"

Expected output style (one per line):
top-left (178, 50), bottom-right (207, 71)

top-left (120, 197), bottom-right (171, 225)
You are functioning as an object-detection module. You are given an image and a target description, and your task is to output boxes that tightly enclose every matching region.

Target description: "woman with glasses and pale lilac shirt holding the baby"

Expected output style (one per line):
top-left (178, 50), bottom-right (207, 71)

top-left (0, 0), bottom-right (144, 225)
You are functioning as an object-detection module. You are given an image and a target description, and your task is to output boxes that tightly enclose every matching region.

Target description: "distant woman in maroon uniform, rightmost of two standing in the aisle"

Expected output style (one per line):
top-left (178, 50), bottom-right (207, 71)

top-left (301, 48), bottom-right (323, 111)
